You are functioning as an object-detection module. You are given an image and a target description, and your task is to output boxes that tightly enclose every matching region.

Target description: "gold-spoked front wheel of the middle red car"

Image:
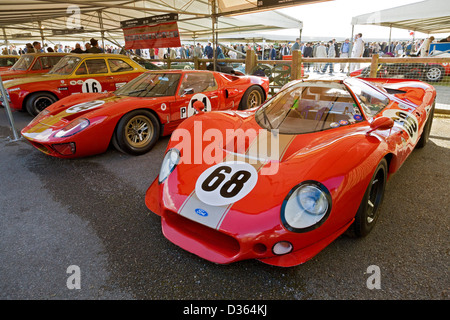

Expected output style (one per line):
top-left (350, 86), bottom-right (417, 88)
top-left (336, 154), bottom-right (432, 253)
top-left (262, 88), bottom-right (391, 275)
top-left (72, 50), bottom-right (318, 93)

top-left (112, 110), bottom-right (160, 155)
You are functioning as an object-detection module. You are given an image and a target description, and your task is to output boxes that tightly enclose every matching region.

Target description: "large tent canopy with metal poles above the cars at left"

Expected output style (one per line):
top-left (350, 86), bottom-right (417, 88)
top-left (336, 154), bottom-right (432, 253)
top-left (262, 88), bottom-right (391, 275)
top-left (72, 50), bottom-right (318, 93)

top-left (0, 0), bottom-right (329, 41)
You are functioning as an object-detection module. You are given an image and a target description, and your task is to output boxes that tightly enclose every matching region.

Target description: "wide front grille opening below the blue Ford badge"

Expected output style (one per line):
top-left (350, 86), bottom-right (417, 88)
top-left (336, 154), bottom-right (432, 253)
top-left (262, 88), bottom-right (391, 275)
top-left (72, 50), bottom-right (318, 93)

top-left (165, 211), bottom-right (240, 258)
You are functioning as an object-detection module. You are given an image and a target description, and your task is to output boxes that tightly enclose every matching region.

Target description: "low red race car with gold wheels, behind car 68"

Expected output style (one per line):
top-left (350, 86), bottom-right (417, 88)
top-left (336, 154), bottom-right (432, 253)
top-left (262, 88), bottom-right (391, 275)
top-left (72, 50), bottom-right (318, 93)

top-left (21, 70), bottom-right (269, 158)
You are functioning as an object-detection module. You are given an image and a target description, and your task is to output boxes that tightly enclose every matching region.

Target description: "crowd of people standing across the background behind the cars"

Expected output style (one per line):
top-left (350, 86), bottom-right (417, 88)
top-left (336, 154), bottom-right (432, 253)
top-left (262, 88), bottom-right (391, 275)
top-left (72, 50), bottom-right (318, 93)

top-left (2, 33), bottom-right (450, 73)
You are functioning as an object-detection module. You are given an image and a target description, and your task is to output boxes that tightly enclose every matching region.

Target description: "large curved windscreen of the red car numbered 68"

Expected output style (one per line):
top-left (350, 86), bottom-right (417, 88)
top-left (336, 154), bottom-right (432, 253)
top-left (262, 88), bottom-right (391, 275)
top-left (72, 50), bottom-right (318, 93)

top-left (255, 81), bottom-right (363, 134)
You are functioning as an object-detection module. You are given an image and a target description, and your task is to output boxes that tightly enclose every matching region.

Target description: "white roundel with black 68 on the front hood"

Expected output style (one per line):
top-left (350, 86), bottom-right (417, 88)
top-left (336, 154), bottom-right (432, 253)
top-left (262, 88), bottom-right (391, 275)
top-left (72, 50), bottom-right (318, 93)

top-left (195, 161), bottom-right (258, 206)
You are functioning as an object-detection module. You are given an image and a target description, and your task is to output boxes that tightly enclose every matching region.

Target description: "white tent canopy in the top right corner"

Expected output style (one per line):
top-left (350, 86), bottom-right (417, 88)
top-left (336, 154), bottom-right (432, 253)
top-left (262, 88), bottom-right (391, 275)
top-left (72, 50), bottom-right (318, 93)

top-left (352, 0), bottom-right (450, 34)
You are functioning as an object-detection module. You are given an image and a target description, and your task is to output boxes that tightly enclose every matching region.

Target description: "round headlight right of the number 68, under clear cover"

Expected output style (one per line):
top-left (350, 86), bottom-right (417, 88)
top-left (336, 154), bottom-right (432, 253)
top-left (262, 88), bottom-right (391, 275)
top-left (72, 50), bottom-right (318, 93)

top-left (281, 181), bottom-right (331, 232)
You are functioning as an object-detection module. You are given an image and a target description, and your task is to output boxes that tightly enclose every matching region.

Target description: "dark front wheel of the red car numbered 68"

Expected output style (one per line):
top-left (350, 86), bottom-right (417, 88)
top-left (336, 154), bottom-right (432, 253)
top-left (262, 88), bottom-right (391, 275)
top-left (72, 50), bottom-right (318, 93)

top-left (352, 159), bottom-right (387, 237)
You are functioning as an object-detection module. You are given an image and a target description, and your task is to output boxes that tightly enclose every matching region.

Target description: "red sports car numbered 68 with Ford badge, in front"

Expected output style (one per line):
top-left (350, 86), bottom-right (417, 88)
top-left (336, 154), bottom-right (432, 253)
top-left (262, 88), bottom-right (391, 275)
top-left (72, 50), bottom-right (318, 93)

top-left (145, 77), bottom-right (436, 267)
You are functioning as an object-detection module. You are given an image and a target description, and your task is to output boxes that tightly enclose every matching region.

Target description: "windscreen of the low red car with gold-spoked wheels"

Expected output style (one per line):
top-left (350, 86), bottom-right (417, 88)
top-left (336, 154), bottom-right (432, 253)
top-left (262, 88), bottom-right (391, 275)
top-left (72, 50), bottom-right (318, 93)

top-left (114, 72), bottom-right (180, 97)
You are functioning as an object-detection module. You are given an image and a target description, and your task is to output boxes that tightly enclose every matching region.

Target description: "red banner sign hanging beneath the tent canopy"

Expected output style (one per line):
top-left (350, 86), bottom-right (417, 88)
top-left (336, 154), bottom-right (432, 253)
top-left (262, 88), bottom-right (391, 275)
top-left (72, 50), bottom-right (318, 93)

top-left (123, 21), bottom-right (181, 49)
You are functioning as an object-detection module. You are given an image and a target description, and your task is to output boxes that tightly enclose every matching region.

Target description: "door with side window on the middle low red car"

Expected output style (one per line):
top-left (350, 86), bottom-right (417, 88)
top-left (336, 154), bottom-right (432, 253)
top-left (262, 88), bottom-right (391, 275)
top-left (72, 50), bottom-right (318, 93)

top-left (171, 71), bottom-right (219, 122)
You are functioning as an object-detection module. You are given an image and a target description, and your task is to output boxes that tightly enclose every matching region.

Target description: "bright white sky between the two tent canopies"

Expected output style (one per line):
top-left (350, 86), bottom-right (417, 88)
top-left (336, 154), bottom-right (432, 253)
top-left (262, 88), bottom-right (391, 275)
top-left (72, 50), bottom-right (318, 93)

top-left (268, 0), bottom-right (447, 41)
